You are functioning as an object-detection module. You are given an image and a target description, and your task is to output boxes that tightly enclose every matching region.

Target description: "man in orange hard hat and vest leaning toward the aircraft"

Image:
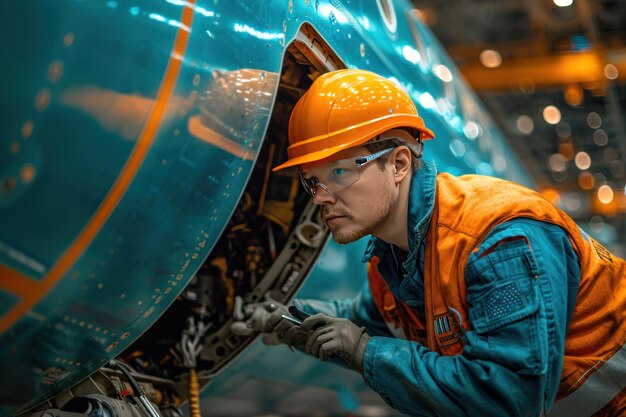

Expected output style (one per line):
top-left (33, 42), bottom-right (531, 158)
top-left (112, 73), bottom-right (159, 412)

top-left (230, 70), bottom-right (626, 416)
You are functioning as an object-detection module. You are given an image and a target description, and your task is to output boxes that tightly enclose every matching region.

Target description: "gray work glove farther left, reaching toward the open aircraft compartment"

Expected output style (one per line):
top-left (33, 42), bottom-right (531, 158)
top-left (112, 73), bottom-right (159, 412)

top-left (230, 297), bottom-right (307, 348)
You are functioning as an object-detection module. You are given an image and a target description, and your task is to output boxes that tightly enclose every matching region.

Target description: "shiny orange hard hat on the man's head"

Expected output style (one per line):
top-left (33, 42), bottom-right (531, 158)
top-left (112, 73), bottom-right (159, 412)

top-left (273, 69), bottom-right (435, 171)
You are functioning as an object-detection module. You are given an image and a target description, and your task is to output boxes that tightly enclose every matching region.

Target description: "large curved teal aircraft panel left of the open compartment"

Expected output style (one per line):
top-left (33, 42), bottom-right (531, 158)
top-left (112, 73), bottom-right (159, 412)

top-left (0, 0), bottom-right (281, 415)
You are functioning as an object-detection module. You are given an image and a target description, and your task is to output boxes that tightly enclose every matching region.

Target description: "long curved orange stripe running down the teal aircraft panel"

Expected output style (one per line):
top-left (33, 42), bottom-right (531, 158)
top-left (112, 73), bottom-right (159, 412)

top-left (0, 0), bottom-right (195, 333)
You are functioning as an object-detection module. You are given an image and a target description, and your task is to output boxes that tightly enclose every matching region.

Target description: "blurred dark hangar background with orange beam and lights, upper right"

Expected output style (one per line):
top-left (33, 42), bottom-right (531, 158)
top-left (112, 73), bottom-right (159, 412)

top-left (413, 0), bottom-right (626, 257)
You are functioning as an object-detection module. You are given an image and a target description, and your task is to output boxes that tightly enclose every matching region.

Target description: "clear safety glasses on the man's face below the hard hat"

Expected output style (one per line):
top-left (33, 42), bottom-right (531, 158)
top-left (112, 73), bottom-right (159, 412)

top-left (299, 148), bottom-right (395, 197)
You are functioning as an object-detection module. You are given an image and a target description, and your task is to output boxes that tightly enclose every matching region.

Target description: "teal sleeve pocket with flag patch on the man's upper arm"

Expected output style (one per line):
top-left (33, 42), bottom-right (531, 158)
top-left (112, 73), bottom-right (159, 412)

top-left (466, 239), bottom-right (548, 375)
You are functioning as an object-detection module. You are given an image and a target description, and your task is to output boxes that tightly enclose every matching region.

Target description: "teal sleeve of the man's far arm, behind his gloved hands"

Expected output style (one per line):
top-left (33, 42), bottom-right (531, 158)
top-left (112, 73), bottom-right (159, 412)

top-left (293, 280), bottom-right (391, 336)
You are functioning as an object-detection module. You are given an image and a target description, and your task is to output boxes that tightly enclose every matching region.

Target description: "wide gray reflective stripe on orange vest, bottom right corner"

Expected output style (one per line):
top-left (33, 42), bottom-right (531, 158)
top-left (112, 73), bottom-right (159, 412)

top-left (548, 345), bottom-right (626, 417)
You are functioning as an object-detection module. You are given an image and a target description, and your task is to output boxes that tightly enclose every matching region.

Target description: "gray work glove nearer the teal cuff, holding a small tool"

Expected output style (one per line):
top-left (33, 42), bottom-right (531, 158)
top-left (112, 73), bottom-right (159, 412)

top-left (300, 314), bottom-right (370, 373)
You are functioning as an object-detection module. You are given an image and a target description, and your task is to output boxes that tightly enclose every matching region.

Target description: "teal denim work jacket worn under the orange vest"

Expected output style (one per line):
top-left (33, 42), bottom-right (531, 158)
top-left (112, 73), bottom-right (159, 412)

top-left (298, 162), bottom-right (580, 416)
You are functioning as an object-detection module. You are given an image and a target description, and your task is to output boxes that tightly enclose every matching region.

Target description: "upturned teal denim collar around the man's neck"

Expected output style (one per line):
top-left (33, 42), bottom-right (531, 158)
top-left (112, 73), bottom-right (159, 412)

top-left (363, 161), bottom-right (437, 270)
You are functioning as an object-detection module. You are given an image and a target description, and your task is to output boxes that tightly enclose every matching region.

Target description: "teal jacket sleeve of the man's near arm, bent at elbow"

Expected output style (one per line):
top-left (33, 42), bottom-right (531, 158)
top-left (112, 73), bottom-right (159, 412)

top-left (364, 219), bottom-right (580, 417)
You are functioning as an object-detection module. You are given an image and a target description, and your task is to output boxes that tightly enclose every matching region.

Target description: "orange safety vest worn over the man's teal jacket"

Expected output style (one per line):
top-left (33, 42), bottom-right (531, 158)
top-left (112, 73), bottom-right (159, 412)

top-left (368, 173), bottom-right (626, 416)
